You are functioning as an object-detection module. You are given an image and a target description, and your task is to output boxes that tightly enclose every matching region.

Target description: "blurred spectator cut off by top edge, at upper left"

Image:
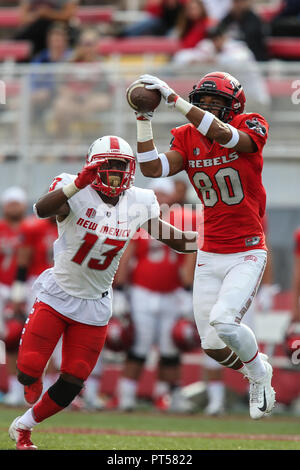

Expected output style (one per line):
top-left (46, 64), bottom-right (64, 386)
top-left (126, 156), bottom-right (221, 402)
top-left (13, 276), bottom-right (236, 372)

top-left (15, 0), bottom-right (78, 55)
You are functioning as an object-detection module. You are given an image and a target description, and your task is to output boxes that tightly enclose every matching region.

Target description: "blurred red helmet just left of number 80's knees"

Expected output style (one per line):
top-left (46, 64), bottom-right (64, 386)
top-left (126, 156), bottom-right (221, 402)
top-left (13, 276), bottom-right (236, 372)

top-left (172, 318), bottom-right (201, 352)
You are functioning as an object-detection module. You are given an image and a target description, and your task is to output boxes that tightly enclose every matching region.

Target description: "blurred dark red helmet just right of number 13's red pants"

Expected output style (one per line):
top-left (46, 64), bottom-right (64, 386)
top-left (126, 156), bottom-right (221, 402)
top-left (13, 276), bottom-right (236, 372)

top-left (105, 315), bottom-right (134, 352)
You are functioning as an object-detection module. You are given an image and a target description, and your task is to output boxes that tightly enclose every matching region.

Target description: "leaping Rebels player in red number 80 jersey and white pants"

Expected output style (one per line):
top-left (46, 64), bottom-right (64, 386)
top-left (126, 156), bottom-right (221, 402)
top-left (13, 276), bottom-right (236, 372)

top-left (136, 72), bottom-right (275, 419)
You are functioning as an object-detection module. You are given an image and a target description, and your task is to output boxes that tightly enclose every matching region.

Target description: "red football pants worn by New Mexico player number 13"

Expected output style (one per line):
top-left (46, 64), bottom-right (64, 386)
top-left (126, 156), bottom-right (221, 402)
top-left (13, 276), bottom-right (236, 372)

top-left (17, 301), bottom-right (107, 381)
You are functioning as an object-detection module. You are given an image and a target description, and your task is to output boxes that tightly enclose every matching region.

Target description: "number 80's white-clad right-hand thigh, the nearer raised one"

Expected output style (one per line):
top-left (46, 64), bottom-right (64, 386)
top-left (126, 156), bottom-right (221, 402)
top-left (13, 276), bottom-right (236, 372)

top-left (210, 250), bottom-right (267, 325)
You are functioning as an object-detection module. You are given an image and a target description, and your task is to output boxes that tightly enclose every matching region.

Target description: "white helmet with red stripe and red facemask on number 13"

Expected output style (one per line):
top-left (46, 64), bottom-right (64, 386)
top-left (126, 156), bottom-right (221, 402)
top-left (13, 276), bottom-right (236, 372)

top-left (86, 135), bottom-right (135, 197)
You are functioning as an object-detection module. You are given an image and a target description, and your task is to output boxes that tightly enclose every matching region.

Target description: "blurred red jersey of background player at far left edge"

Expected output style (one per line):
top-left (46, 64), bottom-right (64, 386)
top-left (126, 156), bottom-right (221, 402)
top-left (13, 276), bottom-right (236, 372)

top-left (0, 220), bottom-right (21, 286)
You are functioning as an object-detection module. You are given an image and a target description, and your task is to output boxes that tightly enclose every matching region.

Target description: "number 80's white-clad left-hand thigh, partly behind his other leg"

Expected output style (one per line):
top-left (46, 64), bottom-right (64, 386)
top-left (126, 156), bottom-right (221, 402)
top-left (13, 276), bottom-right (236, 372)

top-left (193, 252), bottom-right (225, 349)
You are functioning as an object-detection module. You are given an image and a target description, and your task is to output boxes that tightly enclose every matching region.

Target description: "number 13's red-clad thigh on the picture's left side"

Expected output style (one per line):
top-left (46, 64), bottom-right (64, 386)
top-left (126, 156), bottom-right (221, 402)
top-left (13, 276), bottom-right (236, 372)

top-left (17, 302), bottom-right (67, 377)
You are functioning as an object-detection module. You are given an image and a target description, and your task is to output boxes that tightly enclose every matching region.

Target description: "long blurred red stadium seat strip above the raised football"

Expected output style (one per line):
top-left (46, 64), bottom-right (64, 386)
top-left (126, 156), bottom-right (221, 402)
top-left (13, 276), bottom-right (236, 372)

top-left (99, 36), bottom-right (179, 55)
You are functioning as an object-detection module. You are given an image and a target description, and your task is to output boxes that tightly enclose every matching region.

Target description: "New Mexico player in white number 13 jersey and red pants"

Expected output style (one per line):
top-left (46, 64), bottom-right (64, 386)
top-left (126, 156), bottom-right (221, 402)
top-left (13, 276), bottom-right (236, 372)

top-left (9, 136), bottom-right (197, 450)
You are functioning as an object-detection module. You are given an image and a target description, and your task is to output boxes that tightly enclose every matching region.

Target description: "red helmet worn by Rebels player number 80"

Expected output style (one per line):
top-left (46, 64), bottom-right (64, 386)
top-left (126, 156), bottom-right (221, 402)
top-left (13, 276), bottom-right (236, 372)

top-left (189, 72), bottom-right (246, 122)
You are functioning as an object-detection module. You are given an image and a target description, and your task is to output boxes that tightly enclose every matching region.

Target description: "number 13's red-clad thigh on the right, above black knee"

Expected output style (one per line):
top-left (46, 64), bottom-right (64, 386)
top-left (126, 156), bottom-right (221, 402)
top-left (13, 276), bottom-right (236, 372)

top-left (61, 321), bottom-right (107, 381)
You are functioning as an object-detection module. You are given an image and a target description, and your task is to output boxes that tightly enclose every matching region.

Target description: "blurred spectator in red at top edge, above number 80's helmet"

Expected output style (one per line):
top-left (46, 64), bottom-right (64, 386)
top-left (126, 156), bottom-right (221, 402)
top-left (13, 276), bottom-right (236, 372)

top-left (177, 0), bottom-right (211, 49)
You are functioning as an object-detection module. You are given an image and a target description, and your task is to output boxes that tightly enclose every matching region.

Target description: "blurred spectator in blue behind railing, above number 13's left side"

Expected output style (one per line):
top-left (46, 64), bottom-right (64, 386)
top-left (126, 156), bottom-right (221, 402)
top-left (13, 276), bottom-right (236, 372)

top-left (31, 23), bottom-right (71, 111)
